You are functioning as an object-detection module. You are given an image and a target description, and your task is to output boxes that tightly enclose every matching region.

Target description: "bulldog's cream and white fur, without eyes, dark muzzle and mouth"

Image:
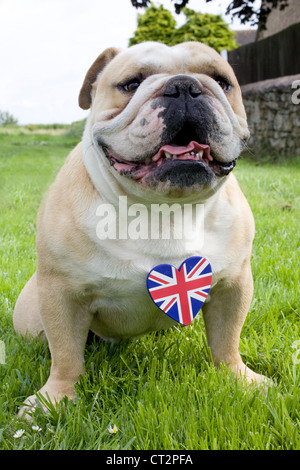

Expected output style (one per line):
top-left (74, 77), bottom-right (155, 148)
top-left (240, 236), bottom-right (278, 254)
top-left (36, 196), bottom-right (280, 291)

top-left (14, 43), bottom-right (270, 415)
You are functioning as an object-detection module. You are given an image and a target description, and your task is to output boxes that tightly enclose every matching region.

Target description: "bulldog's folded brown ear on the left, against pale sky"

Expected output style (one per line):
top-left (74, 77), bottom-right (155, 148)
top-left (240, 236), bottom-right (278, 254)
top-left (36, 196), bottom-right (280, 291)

top-left (78, 47), bottom-right (121, 109)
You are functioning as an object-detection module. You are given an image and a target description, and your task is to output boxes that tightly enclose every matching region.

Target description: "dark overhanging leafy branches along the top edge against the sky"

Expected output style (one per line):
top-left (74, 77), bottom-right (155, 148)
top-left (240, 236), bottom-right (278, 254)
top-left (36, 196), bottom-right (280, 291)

top-left (131, 0), bottom-right (289, 29)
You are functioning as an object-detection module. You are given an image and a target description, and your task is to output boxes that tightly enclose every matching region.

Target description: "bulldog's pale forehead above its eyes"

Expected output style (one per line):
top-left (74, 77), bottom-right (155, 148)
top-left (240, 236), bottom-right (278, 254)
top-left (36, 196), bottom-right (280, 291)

top-left (105, 42), bottom-right (236, 82)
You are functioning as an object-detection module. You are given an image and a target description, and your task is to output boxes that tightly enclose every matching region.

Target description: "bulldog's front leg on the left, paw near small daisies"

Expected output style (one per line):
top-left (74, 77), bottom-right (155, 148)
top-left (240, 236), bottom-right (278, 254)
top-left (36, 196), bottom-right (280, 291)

top-left (19, 276), bottom-right (92, 418)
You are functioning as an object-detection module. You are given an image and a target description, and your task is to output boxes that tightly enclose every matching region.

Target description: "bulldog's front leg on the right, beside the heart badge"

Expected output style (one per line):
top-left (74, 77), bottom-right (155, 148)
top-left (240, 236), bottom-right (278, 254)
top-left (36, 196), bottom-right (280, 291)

top-left (202, 260), bottom-right (268, 383)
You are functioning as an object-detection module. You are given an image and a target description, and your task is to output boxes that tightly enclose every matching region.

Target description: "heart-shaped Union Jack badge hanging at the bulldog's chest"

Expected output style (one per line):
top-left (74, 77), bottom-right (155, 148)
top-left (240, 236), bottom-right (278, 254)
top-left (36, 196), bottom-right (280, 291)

top-left (147, 256), bottom-right (212, 326)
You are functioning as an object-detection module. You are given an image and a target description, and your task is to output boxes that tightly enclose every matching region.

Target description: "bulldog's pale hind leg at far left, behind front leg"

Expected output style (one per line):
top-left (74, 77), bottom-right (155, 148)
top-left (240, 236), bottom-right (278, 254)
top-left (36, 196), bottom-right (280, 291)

top-left (13, 273), bottom-right (46, 340)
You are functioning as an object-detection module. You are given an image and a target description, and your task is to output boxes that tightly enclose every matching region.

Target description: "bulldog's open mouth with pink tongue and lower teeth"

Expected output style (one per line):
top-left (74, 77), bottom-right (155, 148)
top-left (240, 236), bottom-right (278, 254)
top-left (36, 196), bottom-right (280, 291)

top-left (103, 141), bottom-right (237, 180)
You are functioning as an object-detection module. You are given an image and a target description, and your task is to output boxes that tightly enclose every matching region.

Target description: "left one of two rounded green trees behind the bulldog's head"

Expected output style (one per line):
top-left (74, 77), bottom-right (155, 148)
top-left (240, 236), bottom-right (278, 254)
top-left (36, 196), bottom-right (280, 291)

top-left (129, 4), bottom-right (176, 46)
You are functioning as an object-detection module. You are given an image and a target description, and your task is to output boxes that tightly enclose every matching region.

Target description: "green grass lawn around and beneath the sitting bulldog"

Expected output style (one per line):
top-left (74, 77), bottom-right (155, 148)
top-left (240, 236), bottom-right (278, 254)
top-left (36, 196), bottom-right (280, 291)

top-left (0, 130), bottom-right (300, 450)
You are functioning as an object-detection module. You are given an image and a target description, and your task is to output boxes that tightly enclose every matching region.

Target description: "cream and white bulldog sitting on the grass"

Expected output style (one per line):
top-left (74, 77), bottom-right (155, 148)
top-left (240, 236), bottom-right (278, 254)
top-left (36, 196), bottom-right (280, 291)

top-left (13, 42), bottom-right (265, 415)
